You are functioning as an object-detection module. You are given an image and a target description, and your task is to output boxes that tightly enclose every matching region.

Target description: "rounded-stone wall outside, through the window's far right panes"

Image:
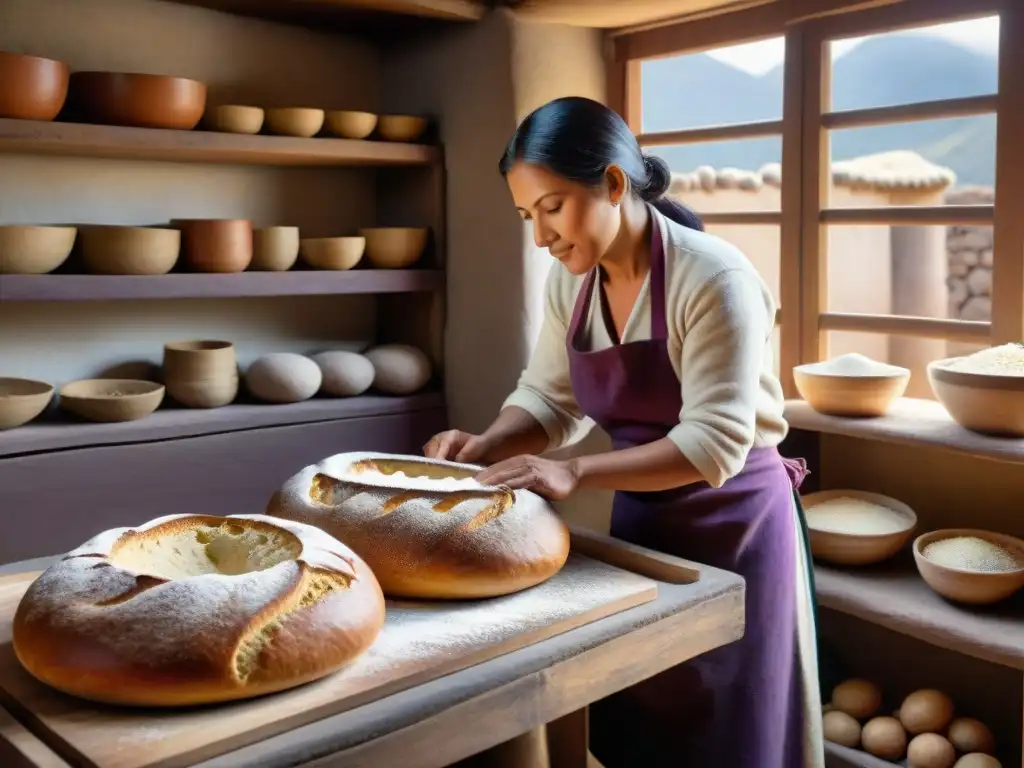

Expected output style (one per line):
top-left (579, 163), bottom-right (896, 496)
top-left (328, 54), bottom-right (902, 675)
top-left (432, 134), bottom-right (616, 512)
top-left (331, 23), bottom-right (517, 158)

top-left (946, 186), bottom-right (995, 321)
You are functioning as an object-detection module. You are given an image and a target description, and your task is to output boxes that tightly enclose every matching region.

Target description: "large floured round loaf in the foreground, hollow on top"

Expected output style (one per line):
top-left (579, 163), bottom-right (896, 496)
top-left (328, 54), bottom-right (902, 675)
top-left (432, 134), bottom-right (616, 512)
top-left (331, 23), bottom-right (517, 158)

top-left (13, 515), bottom-right (384, 707)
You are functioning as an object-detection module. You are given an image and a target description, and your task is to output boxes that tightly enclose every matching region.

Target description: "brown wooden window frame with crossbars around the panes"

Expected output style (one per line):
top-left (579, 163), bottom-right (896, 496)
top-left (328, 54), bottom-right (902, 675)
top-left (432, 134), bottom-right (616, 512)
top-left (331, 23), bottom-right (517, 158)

top-left (606, 0), bottom-right (1024, 397)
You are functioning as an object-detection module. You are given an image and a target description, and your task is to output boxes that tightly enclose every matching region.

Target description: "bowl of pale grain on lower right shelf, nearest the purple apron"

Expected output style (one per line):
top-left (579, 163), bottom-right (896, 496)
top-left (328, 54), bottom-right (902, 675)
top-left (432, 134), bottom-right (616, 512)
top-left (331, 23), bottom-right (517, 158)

top-left (801, 490), bottom-right (918, 565)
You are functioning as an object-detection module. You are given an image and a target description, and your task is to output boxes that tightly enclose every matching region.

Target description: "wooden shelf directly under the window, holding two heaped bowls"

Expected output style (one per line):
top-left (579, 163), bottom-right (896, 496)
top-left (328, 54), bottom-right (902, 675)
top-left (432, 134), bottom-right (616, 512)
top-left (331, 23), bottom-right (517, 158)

top-left (785, 397), bottom-right (1024, 464)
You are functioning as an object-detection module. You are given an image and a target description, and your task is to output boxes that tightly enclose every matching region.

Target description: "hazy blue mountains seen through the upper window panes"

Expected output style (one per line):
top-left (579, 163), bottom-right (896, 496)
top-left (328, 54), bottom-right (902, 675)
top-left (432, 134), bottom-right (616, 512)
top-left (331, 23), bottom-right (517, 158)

top-left (641, 33), bottom-right (998, 185)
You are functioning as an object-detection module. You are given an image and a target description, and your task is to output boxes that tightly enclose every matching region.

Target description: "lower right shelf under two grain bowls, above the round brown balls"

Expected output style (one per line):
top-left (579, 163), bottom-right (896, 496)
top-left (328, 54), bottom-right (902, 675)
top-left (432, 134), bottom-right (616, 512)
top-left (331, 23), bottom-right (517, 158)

top-left (814, 554), bottom-right (1024, 670)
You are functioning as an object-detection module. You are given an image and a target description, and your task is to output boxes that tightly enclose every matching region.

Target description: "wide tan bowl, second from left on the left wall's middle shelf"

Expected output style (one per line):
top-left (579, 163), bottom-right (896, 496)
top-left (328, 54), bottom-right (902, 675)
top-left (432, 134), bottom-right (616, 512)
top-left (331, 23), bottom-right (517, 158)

top-left (79, 224), bottom-right (181, 274)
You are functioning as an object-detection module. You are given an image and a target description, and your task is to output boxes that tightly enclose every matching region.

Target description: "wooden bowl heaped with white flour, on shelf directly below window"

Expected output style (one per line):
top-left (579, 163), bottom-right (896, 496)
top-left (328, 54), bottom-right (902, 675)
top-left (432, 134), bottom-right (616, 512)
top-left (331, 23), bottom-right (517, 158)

top-left (793, 352), bottom-right (910, 418)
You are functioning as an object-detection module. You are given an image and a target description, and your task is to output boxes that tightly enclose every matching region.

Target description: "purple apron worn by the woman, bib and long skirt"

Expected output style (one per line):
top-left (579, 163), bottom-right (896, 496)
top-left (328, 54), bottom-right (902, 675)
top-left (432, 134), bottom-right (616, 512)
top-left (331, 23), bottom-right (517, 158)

top-left (566, 220), bottom-right (804, 768)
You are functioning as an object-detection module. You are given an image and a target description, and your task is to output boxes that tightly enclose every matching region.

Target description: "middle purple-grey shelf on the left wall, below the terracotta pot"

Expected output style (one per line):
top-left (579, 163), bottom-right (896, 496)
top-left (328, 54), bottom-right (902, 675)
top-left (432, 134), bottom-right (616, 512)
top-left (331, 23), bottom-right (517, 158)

top-left (0, 269), bottom-right (444, 301)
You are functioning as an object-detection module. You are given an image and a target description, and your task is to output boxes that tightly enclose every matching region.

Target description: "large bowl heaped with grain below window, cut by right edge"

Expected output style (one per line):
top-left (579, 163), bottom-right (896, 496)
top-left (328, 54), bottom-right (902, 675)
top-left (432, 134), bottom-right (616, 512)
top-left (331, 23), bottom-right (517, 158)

top-left (928, 343), bottom-right (1024, 437)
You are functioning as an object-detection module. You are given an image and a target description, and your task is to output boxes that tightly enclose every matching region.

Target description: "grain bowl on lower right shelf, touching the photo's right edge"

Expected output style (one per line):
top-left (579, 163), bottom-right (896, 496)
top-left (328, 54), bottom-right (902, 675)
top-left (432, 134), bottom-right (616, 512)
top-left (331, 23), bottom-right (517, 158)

top-left (913, 528), bottom-right (1024, 605)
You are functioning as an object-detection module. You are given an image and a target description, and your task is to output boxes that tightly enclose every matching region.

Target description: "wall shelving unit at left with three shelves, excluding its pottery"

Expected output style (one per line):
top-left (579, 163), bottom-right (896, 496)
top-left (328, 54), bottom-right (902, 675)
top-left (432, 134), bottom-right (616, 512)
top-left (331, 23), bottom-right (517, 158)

top-left (0, 0), bottom-right (450, 561)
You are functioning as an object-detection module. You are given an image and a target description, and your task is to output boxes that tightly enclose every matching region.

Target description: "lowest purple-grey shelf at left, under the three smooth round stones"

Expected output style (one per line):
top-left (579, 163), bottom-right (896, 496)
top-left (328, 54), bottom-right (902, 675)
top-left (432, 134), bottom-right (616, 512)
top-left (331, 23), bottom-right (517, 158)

top-left (0, 392), bottom-right (444, 457)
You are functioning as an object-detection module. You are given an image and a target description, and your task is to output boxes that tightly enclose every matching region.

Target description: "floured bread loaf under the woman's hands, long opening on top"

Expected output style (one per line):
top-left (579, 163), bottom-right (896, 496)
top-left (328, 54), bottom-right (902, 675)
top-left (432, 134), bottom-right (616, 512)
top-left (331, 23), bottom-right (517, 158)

top-left (267, 453), bottom-right (569, 599)
